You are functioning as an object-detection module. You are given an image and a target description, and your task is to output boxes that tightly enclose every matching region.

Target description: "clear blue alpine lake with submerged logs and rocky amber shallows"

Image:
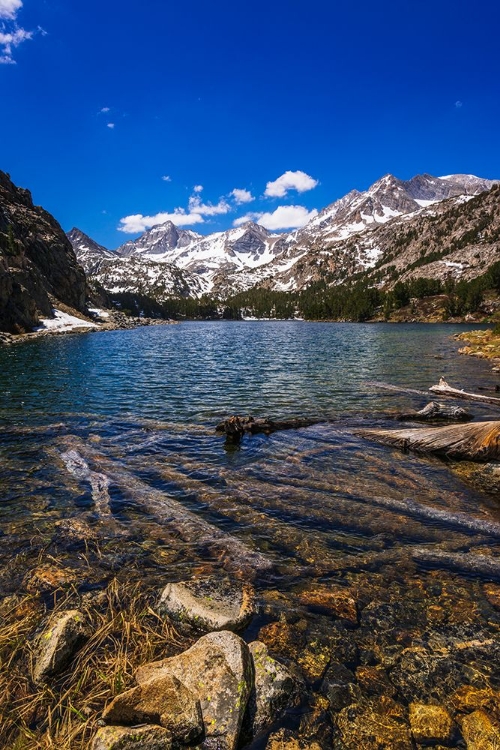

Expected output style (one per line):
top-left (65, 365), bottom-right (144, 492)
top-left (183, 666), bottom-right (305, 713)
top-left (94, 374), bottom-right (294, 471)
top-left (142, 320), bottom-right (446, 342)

top-left (0, 321), bottom-right (500, 750)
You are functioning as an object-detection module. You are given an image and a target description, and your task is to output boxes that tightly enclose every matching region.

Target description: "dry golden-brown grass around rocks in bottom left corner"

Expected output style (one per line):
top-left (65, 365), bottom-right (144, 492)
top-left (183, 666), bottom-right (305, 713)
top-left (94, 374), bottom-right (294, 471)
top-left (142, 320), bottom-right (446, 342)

top-left (0, 580), bottom-right (190, 750)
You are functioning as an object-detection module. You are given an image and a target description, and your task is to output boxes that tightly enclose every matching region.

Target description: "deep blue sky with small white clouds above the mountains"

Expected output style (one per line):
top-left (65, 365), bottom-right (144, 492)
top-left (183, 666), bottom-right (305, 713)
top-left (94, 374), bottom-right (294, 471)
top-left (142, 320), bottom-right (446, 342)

top-left (0, 0), bottom-right (500, 248)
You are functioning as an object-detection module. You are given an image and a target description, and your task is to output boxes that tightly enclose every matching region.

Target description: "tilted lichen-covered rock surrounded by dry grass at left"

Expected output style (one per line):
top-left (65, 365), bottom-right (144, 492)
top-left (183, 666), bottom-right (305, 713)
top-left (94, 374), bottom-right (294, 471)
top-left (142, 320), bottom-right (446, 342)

top-left (33, 609), bottom-right (87, 683)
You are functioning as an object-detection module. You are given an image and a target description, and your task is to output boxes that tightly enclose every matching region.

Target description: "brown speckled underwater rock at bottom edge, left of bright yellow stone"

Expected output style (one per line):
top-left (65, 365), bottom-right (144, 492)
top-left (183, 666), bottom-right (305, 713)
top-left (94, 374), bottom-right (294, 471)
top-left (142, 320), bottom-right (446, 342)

top-left (334, 698), bottom-right (413, 750)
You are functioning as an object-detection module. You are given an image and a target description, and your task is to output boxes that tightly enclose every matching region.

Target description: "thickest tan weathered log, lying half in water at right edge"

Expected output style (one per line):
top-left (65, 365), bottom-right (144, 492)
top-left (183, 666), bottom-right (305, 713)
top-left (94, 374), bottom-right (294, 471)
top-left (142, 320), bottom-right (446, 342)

top-left (356, 422), bottom-right (500, 461)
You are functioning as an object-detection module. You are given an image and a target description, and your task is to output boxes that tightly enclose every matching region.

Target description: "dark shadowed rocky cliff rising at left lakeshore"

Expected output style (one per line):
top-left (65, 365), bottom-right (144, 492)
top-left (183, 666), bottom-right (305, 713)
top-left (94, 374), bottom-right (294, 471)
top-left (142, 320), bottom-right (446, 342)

top-left (0, 172), bottom-right (86, 333)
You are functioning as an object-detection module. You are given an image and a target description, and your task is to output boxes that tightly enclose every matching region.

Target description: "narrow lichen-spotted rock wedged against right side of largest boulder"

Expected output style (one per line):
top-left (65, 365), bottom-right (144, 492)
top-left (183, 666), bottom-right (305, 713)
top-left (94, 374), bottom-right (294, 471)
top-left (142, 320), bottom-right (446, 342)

top-left (249, 641), bottom-right (296, 736)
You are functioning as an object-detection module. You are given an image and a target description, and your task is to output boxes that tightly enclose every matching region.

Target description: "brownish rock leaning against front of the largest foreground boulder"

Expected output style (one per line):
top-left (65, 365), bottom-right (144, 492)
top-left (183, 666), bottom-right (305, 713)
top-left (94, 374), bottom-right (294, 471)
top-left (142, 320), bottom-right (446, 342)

top-left (103, 675), bottom-right (203, 743)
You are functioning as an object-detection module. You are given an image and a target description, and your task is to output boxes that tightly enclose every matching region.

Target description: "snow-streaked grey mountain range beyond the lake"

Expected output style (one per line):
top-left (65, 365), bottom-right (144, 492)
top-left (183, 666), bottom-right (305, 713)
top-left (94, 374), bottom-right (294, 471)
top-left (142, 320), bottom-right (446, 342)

top-left (69, 174), bottom-right (495, 298)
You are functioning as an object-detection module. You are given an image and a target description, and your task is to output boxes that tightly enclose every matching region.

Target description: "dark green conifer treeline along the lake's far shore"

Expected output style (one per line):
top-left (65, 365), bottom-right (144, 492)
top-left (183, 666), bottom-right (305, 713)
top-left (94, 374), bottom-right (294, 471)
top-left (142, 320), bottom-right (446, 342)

top-left (108, 261), bottom-right (500, 322)
